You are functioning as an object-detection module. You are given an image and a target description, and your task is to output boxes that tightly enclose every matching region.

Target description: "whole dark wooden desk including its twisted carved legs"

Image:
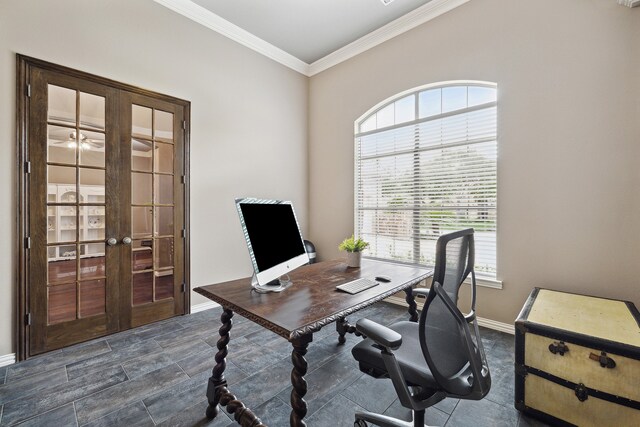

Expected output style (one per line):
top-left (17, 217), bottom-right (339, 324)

top-left (194, 259), bottom-right (433, 427)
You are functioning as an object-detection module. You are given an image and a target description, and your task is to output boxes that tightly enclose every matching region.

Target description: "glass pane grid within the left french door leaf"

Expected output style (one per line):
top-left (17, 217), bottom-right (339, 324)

top-left (46, 84), bottom-right (106, 325)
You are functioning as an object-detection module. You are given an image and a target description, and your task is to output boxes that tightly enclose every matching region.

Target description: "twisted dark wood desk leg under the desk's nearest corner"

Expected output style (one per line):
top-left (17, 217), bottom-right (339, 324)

top-left (289, 334), bottom-right (313, 427)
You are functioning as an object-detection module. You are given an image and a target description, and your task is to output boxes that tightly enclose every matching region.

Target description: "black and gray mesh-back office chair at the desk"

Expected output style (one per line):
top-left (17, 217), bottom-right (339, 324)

top-left (352, 228), bottom-right (491, 427)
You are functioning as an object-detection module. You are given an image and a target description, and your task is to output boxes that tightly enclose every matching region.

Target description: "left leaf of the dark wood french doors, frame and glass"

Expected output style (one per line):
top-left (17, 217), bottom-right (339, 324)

top-left (27, 70), bottom-right (119, 355)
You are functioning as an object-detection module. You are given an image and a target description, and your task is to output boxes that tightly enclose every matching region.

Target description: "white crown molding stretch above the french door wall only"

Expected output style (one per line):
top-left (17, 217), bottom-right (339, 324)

top-left (153, 0), bottom-right (309, 76)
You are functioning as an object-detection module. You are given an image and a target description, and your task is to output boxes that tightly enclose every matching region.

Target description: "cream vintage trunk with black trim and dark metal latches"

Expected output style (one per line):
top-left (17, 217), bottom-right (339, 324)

top-left (515, 288), bottom-right (640, 427)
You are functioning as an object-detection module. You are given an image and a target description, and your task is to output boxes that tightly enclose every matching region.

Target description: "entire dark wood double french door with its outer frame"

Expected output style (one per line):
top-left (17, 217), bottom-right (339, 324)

top-left (18, 56), bottom-right (189, 358)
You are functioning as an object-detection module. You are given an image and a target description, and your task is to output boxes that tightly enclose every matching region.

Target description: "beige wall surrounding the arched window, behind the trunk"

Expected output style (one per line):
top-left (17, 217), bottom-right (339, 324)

top-left (309, 0), bottom-right (640, 323)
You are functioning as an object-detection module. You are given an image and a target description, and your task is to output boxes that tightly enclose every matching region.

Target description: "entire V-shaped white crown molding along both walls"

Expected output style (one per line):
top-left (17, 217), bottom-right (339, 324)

top-left (153, 0), bottom-right (470, 77)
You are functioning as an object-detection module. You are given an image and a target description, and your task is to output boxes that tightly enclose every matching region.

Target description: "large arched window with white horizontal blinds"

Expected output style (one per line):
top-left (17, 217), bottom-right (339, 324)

top-left (355, 81), bottom-right (497, 278)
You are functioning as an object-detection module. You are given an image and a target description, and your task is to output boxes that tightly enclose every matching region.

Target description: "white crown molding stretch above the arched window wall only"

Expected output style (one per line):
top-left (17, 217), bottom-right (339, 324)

top-left (309, 0), bottom-right (470, 76)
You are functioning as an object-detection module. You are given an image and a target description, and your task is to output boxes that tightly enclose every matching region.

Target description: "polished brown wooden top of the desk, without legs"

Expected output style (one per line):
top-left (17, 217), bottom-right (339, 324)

top-left (194, 259), bottom-right (433, 339)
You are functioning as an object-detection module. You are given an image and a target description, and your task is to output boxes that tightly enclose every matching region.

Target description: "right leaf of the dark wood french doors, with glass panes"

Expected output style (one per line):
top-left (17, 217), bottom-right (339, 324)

top-left (119, 92), bottom-right (186, 327)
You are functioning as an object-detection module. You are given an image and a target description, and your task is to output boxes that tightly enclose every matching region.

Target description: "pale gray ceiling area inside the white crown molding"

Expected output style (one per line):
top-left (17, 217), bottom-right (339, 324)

top-left (193, 0), bottom-right (430, 64)
